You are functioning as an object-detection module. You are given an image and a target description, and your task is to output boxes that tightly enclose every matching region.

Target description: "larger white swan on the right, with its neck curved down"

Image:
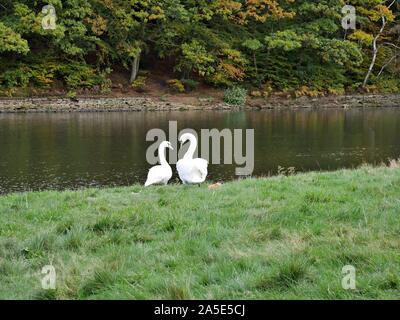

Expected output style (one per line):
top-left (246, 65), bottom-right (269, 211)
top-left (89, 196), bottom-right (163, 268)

top-left (176, 133), bottom-right (208, 184)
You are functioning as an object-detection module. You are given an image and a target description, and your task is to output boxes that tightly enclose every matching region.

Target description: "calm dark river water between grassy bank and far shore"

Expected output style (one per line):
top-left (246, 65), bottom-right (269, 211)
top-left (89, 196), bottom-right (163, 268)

top-left (0, 108), bottom-right (400, 193)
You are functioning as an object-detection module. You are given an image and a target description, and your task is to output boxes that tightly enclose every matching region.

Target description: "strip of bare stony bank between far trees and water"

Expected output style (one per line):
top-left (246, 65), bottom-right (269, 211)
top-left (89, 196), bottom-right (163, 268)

top-left (0, 94), bottom-right (400, 113)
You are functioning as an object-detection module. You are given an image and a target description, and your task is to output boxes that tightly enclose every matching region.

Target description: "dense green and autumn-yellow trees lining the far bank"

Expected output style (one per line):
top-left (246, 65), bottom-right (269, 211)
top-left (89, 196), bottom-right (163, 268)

top-left (0, 0), bottom-right (400, 96)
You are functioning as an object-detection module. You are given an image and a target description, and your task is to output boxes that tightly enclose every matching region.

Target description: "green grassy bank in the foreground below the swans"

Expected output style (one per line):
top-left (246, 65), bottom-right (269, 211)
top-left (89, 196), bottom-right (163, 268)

top-left (0, 167), bottom-right (400, 299)
